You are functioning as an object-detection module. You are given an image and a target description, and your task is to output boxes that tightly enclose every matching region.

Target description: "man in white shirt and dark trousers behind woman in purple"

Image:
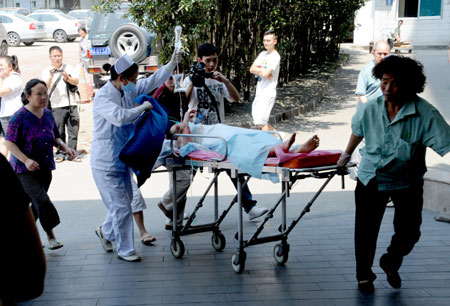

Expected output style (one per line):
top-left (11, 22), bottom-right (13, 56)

top-left (42, 46), bottom-right (81, 162)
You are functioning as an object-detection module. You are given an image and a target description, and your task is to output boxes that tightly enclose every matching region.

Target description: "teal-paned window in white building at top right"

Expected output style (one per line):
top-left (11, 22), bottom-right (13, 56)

top-left (398, 0), bottom-right (442, 18)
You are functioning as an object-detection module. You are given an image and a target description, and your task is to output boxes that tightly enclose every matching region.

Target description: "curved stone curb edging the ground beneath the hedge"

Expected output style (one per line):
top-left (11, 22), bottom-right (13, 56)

top-left (236, 59), bottom-right (348, 128)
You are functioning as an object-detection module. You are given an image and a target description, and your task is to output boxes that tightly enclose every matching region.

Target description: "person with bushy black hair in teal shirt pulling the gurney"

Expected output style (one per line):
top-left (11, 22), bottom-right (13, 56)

top-left (338, 56), bottom-right (450, 292)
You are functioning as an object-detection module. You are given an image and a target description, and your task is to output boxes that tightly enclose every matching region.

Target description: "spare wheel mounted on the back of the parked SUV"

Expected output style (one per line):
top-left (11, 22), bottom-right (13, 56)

top-left (109, 24), bottom-right (147, 63)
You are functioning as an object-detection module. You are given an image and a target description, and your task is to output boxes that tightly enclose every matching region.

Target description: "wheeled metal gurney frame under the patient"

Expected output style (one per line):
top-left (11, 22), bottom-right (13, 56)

top-left (166, 134), bottom-right (354, 273)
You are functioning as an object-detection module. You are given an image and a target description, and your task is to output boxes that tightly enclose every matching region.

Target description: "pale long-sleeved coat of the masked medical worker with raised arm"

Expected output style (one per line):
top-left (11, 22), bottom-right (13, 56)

top-left (91, 66), bottom-right (172, 172)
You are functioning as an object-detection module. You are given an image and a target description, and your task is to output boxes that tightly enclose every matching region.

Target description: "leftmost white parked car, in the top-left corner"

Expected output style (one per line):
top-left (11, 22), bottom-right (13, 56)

top-left (0, 14), bottom-right (47, 47)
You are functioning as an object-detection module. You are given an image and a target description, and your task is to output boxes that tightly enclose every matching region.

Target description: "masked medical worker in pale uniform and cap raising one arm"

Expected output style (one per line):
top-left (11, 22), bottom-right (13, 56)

top-left (91, 52), bottom-right (181, 262)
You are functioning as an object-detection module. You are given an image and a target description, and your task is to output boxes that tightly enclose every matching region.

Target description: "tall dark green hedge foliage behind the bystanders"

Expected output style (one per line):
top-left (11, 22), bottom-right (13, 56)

top-left (100, 0), bottom-right (365, 100)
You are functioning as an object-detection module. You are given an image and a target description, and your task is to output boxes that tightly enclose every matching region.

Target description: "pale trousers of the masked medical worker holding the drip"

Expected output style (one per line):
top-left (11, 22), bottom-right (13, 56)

top-left (92, 169), bottom-right (136, 256)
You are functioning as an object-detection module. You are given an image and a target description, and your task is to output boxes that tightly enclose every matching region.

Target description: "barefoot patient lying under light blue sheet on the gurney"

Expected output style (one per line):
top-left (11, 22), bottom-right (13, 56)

top-left (160, 112), bottom-right (320, 178)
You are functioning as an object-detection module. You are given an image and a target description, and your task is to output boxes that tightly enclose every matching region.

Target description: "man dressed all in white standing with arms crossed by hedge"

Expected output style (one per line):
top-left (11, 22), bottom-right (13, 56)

top-left (250, 30), bottom-right (280, 131)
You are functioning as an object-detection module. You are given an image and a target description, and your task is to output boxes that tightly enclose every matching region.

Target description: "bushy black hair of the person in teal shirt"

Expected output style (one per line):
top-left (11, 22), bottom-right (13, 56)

top-left (372, 55), bottom-right (426, 98)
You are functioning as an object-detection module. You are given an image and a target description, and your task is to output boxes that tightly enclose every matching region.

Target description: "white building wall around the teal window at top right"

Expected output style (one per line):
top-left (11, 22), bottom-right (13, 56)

top-left (354, 0), bottom-right (450, 46)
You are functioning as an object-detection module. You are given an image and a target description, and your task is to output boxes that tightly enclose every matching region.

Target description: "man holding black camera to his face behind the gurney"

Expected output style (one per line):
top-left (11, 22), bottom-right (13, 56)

top-left (158, 43), bottom-right (268, 229)
